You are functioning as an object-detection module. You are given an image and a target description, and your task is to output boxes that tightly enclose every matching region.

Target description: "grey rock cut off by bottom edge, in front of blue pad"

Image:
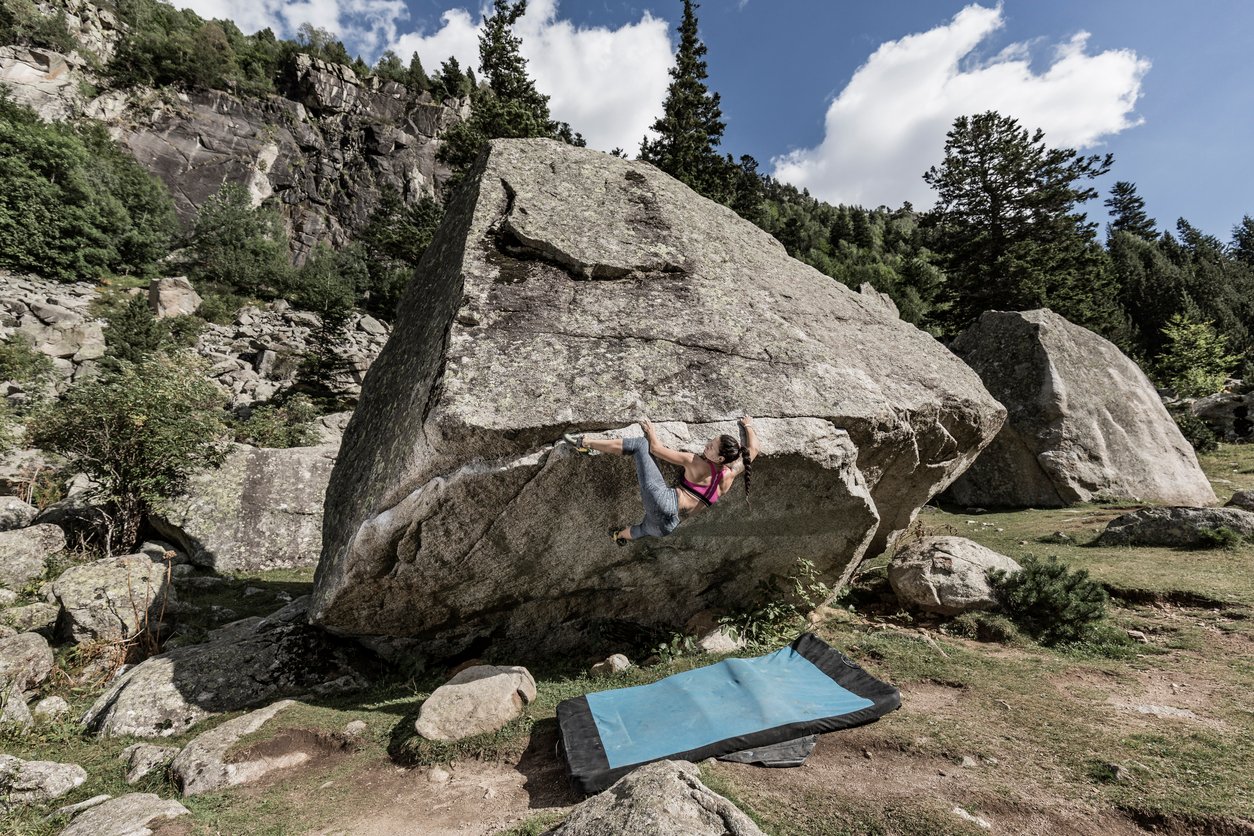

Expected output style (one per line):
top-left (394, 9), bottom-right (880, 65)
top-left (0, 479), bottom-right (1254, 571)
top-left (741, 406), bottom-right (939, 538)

top-left (545, 761), bottom-right (762, 836)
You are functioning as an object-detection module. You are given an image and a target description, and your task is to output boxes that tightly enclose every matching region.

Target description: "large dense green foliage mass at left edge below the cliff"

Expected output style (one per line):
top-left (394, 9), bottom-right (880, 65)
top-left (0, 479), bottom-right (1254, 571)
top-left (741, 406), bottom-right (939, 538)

top-left (0, 89), bottom-right (177, 281)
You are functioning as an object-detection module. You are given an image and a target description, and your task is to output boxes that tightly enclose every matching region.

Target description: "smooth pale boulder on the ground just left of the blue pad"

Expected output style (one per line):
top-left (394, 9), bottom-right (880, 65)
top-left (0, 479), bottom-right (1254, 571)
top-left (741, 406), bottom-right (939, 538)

top-left (414, 664), bottom-right (535, 741)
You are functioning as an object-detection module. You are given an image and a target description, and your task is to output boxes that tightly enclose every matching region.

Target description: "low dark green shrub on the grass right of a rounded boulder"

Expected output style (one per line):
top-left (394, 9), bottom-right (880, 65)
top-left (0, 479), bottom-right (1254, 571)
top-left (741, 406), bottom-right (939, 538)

top-left (988, 556), bottom-right (1109, 644)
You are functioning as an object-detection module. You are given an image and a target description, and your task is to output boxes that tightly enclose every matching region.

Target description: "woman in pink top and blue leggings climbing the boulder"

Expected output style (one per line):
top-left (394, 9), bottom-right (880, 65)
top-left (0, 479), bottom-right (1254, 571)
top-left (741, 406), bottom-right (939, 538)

top-left (562, 415), bottom-right (757, 545)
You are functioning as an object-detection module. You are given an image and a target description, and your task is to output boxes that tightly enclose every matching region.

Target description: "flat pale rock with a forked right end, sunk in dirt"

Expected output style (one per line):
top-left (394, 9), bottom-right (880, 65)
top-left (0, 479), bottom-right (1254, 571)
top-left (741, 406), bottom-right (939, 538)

top-left (169, 699), bottom-right (310, 796)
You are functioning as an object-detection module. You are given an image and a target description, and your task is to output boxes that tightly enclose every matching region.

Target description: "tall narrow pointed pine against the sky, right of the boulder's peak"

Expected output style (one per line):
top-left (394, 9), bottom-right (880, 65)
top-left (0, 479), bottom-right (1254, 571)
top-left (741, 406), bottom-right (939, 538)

top-left (640, 0), bottom-right (729, 202)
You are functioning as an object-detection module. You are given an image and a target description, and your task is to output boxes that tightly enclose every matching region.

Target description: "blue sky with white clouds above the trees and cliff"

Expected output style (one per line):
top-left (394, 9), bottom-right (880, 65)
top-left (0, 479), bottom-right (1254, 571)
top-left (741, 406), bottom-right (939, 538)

top-left (176, 0), bottom-right (1254, 241)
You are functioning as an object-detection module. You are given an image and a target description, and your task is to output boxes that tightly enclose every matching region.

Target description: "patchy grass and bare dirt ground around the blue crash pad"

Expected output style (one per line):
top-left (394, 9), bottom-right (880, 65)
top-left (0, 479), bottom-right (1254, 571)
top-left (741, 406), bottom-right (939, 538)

top-left (0, 445), bottom-right (1254, 836)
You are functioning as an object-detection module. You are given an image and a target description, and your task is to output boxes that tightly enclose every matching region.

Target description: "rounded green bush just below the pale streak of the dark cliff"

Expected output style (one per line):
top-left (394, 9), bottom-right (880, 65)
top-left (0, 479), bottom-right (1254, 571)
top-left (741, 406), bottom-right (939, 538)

top-left (188, 183), bottom-right (292, 298)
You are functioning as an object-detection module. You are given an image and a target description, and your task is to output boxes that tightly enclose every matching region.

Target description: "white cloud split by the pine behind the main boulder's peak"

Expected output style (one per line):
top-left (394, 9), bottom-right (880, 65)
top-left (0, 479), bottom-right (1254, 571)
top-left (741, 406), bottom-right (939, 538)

top-left (391, 0), bottom-right (675, 152)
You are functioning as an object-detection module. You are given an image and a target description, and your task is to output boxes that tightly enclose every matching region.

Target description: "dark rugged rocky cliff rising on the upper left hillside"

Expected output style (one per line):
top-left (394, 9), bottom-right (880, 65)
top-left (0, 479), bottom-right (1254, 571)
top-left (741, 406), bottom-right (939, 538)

top-left (0, 0), bottom-right (469, 263)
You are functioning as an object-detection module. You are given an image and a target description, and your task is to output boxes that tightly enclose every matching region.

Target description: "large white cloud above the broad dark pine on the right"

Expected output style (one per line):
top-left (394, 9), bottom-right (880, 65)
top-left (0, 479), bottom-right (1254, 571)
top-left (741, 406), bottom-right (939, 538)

top-left (772, 5), bottom-right (1150, 208)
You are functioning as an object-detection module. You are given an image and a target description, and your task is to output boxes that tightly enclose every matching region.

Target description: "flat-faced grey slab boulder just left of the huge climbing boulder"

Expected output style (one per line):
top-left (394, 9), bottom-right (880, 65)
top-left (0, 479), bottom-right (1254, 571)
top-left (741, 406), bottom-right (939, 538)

top-left (150, 444), bottom-right (337, 572)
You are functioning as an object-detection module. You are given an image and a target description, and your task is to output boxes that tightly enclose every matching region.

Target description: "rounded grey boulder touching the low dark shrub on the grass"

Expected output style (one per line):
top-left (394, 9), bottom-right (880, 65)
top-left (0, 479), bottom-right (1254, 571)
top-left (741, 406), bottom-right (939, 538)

top-left (888, 536), bottom-right (1021, 615)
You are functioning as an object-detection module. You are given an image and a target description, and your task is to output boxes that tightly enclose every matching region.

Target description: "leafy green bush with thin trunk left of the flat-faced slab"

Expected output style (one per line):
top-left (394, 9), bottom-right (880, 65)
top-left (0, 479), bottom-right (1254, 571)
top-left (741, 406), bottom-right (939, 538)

top-left (30, 353), bottom-right (227, 549)
